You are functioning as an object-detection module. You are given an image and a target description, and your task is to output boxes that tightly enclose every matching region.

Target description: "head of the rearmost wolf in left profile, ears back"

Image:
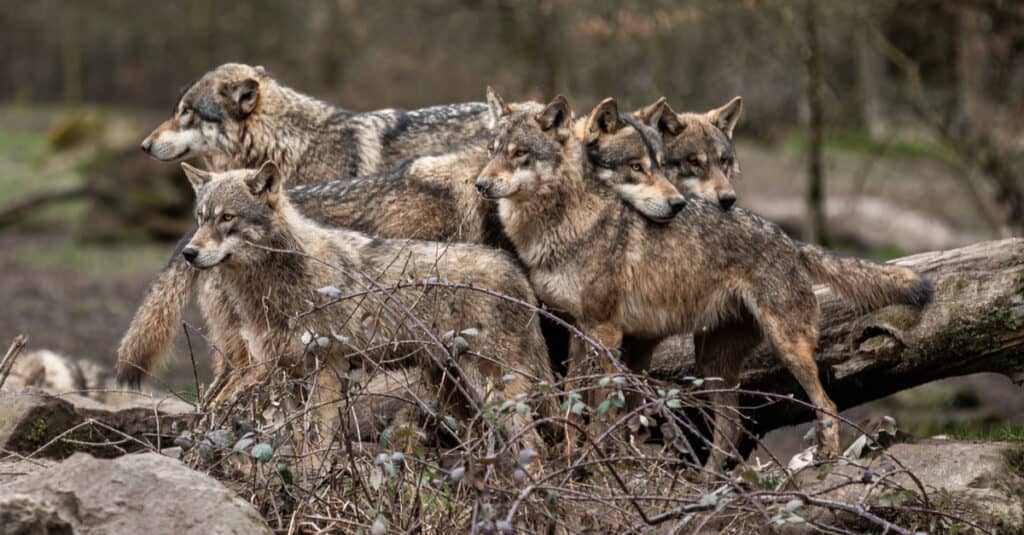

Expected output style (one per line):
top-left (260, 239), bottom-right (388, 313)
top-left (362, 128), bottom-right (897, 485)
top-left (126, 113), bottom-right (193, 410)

top-left (141, 64), bottom-right (271, 162)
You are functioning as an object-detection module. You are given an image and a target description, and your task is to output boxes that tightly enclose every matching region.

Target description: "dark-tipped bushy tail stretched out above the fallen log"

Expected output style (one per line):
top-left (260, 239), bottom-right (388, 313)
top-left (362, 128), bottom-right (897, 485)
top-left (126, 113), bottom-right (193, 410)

top-left (797, 242), bottom-right (934, 311)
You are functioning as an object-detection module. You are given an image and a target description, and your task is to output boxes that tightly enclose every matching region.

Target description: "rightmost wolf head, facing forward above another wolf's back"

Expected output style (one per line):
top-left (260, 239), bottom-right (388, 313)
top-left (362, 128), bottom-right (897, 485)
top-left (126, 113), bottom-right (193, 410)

top-left (633, 96), bottom-right (743, 210)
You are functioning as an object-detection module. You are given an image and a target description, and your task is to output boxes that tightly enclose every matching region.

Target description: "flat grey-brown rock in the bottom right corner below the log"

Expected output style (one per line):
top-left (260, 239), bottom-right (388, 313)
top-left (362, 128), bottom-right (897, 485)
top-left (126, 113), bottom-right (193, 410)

top-left (798, 440), bottom-right (1024, 533)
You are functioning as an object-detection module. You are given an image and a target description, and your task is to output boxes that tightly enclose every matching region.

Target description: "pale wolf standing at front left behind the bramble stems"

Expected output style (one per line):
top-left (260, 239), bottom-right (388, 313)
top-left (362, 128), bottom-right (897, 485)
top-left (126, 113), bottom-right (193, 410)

top-left (181, 162), bottom-right (555, 448)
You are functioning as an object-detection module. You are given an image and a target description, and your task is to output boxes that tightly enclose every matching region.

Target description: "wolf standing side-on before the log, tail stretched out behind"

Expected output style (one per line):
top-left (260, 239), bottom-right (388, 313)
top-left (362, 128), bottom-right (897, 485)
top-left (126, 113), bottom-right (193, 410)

top-left (477, 93), bottom-right (932, 469)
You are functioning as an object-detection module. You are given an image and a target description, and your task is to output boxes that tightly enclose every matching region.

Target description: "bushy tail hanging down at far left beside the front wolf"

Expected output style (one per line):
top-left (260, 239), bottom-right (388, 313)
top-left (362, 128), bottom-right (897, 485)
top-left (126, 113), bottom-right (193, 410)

top-left (117, 233), bottom-right (199, 388)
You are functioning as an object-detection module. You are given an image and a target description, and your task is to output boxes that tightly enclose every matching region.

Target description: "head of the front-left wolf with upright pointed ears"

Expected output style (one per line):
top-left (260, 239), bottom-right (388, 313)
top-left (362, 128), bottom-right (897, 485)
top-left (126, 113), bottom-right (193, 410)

top-left (181, 156), bottom-right (287, 270)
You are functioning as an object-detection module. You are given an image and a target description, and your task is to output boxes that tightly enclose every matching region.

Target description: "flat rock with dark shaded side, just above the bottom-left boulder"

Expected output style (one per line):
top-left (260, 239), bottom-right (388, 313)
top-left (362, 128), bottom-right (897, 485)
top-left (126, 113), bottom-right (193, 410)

top-left (0, 388), bottom-right (191, 458)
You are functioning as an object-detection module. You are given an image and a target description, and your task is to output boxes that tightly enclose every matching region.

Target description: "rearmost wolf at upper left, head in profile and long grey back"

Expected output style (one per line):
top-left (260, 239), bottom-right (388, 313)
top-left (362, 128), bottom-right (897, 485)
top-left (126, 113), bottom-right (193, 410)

top-left (141, 64), bottom-right (488, 181)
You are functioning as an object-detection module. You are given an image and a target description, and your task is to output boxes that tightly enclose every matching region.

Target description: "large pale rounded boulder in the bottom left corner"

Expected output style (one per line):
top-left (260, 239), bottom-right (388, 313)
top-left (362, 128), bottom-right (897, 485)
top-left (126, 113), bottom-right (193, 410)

top-left (0, 453), bottom-right (270, 535)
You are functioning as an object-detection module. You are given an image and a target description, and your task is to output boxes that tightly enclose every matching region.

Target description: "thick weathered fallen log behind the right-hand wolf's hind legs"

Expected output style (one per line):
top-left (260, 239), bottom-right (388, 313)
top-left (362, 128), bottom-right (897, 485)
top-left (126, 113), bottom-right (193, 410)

top-left (651, 239), bottom-right (1024, 435)
